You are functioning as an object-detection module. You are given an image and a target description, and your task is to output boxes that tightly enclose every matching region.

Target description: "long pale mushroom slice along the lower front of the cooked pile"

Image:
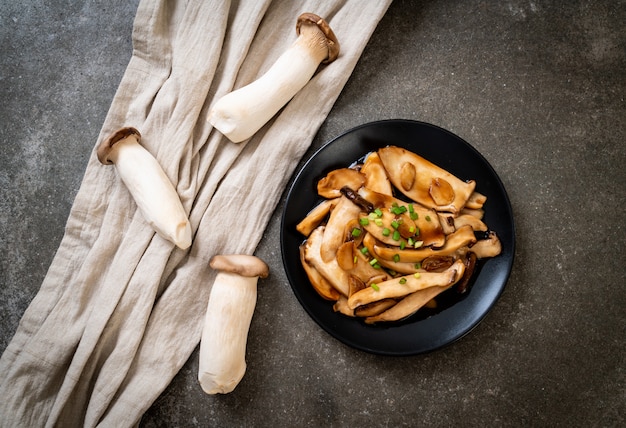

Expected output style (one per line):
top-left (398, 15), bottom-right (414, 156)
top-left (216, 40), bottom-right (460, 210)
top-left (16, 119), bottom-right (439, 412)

top-left (348, 260), bottom-right (465, 309)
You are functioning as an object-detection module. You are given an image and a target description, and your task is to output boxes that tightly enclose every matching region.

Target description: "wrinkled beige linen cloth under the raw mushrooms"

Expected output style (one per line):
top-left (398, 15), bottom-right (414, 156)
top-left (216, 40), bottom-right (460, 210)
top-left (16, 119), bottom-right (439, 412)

top-left (0, 0), bottom-right (391, 427)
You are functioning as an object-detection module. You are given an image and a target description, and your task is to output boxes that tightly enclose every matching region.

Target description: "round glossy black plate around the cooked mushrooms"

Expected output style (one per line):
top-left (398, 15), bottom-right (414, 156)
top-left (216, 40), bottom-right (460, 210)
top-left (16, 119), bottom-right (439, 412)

top-left (280, 120), bottom-right (515, 355)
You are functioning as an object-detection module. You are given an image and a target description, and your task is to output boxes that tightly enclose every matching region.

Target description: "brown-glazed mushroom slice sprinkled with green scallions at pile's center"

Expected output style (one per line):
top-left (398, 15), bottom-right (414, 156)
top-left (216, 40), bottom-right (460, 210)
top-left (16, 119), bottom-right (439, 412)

top-left (359, 187), bottom-right (446, 247)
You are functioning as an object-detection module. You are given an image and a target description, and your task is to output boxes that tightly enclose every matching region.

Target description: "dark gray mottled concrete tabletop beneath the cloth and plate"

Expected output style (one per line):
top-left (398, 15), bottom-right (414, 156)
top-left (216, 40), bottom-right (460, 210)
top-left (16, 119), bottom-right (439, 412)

top-left (0, 0), bottom-right (626, 427)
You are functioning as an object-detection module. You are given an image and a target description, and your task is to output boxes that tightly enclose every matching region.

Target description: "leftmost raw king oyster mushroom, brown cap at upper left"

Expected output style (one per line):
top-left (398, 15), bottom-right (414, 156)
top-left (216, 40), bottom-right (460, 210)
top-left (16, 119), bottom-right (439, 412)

top-left (97, 128), bottom-right (191, 249)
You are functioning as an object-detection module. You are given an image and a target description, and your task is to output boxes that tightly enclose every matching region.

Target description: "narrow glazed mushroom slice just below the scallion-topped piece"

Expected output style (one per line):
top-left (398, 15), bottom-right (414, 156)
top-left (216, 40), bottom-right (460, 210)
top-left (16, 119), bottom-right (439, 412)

top-left (374, 226), bottom-right (476, 263)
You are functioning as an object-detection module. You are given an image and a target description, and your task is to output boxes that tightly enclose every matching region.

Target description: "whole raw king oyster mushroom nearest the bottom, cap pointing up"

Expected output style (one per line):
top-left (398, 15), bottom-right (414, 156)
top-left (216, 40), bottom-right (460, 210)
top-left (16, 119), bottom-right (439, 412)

top-left (198, 255), bottom-right (269, 394)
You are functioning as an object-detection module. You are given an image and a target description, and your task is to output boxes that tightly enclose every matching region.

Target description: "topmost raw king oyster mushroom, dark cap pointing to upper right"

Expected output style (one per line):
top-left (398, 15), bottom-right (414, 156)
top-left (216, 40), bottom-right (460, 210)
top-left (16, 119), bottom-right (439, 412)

top-left (208, 13), bottom-right (339, 143)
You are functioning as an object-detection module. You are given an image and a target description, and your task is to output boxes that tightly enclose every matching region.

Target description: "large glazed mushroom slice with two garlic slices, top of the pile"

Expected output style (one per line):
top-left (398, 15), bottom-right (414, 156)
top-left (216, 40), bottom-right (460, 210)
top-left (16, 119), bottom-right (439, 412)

top-left (378, 146), bottom-right (476, 213)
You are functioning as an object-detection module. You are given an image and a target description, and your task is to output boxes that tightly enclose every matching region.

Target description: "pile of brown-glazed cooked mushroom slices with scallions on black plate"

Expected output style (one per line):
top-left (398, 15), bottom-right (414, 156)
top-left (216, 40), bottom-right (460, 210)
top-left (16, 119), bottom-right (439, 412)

top-left (297, 146), bottom-right (501, 324)
